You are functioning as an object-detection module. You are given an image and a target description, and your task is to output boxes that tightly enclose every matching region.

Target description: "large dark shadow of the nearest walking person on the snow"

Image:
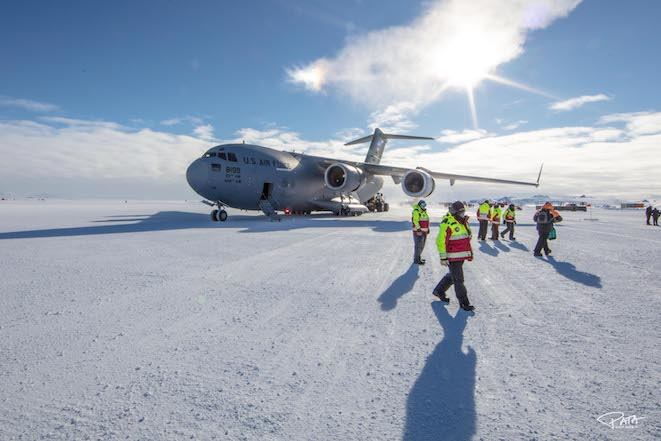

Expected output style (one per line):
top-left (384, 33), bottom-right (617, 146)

top-left (404, 302), bottom-right (477, 441)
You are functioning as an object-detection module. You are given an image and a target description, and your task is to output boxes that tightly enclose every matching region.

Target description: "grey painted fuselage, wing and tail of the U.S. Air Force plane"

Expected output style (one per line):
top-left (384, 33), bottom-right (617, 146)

top-left (186, 129), bottom-right (539, 217)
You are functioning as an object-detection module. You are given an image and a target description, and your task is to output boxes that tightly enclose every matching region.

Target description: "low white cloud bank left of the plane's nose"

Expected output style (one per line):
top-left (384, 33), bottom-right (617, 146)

top-left (0, 119), bottom-right (210, 184)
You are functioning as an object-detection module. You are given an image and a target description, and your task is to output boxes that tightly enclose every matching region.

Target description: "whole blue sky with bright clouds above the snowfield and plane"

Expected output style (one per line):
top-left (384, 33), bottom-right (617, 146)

top-left (0, 0), bottom-right (661, 198)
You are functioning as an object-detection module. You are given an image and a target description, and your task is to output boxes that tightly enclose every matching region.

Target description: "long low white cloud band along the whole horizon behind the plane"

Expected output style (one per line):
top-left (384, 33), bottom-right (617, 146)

top-left (0, 112), bottom-right (661, 199)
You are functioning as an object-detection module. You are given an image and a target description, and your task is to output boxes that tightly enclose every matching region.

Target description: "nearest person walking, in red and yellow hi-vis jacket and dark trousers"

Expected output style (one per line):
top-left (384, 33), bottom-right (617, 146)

top-left (432, 201), bottom-right (475, 311)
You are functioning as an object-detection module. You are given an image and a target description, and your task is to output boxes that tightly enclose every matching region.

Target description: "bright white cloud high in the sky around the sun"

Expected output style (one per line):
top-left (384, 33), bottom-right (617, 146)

top-left (287, 0), bottom-right (580, 108)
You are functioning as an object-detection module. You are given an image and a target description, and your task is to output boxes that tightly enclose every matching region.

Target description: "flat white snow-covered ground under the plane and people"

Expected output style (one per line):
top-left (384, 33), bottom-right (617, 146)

top-left (0, 201), bottom-right (661, 440)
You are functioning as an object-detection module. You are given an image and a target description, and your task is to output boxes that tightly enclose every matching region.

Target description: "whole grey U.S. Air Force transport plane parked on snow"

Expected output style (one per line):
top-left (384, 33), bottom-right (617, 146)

top-left (186, 128), bottom-right (542, 221)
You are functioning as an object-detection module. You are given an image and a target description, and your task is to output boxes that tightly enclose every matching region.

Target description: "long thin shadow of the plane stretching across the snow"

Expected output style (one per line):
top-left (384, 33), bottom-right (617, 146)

top-left (0, 211), bottom-right (410, 240)
